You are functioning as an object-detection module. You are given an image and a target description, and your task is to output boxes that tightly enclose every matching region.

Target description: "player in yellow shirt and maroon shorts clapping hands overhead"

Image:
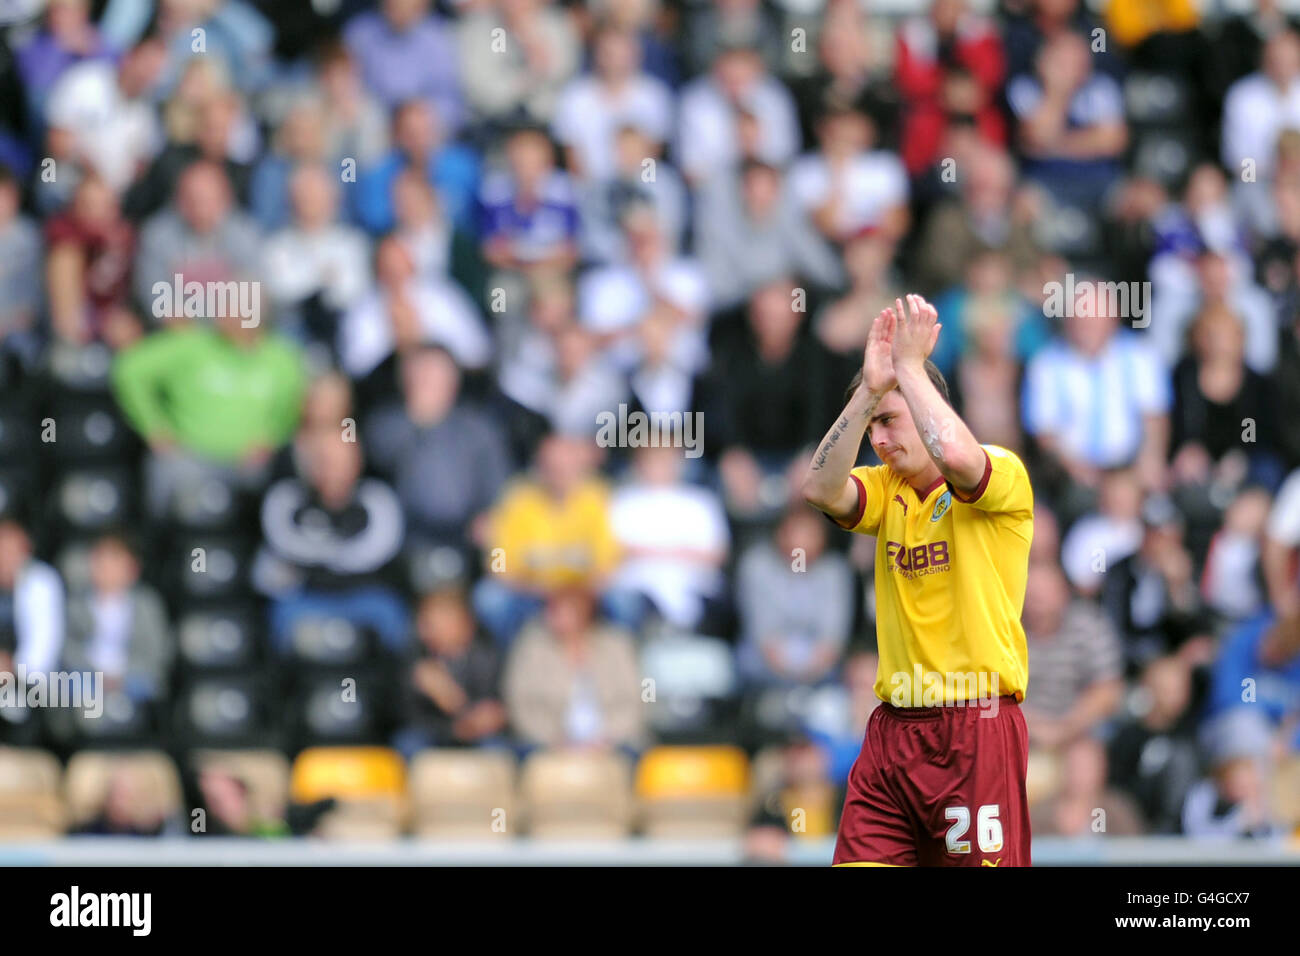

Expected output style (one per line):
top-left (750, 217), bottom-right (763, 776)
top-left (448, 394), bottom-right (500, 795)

top-left (803, 295), bottom-right (1034, 866)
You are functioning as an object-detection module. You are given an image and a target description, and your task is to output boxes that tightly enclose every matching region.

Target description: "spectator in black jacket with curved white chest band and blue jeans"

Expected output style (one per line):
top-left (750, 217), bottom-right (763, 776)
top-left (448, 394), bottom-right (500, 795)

top-left (252, 429), bottom-right (410, 654)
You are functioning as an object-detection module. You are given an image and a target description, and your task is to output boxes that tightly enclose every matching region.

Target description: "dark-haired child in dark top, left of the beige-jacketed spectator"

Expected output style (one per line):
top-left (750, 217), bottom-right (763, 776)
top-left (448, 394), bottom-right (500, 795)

top-left (393, 588), bottom-right (506, 760)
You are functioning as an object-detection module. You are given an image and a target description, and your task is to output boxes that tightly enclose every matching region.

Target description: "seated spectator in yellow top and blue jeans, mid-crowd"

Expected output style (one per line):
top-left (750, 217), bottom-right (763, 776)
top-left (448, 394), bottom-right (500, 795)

top-left (473, 434), bottom-right (620, 644)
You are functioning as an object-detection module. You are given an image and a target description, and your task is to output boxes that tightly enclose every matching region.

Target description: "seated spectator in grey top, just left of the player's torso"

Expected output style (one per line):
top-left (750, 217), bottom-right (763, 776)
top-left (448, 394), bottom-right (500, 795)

top-left (736, 503), bottom-right (853, 687)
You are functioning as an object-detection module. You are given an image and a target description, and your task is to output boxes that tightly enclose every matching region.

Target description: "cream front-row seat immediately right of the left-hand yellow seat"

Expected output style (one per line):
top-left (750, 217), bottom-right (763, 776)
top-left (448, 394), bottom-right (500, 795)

top-left (411, 749), bottom-right (515, 839)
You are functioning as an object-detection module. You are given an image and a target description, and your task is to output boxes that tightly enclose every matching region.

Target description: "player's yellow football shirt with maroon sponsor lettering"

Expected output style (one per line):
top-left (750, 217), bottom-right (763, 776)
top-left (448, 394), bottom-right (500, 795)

top-left (841, 445), bottom-right (1034, 706)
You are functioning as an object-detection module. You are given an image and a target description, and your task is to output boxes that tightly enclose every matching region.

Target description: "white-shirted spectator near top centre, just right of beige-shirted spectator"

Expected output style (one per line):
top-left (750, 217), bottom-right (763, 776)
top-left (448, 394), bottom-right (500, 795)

top-left (553, 25), bottom-right (673, 181)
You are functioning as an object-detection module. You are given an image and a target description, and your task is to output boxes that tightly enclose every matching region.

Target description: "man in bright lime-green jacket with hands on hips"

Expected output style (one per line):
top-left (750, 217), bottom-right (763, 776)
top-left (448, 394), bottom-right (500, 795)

top-left (112, 310), bottom-right (306, 515)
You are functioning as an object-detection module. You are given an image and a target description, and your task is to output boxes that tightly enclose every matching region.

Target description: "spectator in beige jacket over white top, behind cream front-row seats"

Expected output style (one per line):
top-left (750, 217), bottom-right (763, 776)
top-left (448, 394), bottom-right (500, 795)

top-left (504, 584), bottom-right (645, 753)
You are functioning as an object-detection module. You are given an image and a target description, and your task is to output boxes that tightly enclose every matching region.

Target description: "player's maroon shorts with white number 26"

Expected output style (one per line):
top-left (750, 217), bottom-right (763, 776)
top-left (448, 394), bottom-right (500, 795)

top-left (835, 696), bottom-right (1030, 866)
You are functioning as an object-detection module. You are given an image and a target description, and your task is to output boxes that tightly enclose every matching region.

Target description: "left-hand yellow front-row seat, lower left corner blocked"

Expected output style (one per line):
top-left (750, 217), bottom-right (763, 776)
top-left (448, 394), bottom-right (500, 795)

top-left (290, 747), bottom-right (407, 840)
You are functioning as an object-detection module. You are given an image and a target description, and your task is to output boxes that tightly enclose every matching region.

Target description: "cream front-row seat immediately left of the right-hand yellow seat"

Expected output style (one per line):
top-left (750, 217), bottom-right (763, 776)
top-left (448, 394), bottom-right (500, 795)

top-left (520, 750), bottom-right (633, 840)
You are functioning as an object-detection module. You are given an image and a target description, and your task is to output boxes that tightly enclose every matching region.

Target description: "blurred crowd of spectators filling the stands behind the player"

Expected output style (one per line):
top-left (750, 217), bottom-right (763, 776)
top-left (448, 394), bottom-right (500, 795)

top-left (0, 0), bottom-right (1300, 845)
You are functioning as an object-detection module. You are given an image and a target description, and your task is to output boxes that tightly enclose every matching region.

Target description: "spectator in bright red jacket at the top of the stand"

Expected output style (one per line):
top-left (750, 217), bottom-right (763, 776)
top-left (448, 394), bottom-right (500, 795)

top-left (894, 0), bottom-right (1006, 176)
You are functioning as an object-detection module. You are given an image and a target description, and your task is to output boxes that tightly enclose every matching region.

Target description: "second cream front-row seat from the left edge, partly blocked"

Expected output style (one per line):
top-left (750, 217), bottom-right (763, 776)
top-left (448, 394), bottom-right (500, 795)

top-left (64, 750), bottom-right (182, 827)
